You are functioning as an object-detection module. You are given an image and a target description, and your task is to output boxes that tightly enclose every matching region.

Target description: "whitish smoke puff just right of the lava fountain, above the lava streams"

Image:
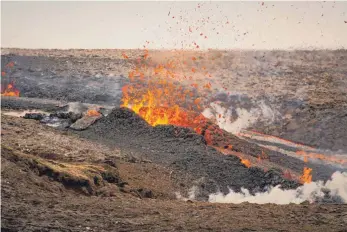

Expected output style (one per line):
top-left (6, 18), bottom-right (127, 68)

top-left (202, 98), bottom-right (277, 134)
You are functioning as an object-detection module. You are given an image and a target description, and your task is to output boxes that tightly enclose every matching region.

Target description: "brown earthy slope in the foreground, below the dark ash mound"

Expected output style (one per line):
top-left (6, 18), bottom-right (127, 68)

top-left (1, 112), bottom-right (347, 231)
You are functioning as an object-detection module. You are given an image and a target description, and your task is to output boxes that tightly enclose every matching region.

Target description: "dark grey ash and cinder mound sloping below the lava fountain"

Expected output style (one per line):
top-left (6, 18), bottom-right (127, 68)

top-left (78, 108), bottom-right (299, 199)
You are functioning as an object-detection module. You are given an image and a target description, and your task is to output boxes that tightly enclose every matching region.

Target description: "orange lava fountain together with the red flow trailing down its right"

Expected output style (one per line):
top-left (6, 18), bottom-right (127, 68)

top-left (121, 50), bottom-right (251, 167)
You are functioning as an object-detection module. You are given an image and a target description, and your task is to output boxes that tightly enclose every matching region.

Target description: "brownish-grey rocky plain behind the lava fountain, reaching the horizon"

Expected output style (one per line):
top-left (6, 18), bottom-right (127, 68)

top-left (1, 49), bottom-right (347, 152)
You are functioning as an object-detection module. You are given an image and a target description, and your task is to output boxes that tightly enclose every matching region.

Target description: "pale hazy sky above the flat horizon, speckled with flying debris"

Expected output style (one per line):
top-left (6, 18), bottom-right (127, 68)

top-left (1, 1), bottom-right (347, 49)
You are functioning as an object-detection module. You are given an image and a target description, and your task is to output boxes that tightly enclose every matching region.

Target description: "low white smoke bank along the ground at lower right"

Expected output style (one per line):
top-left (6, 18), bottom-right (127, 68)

top-left (209, 172), bottom-right (347, 205)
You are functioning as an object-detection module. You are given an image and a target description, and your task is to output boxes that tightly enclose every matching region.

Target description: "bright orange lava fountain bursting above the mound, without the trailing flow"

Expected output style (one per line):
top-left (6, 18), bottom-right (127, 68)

top-left (121, 50), bottom-right (211, 129)
